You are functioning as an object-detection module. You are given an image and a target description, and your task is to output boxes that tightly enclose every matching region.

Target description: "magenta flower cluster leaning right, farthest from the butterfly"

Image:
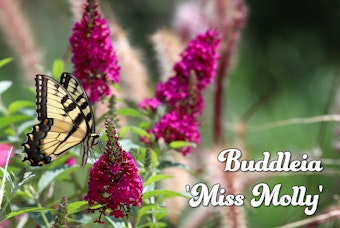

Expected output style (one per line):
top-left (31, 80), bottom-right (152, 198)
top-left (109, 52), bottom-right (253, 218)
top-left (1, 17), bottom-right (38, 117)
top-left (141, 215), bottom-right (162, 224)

top-left (139, 30), bottom-right (219, 155)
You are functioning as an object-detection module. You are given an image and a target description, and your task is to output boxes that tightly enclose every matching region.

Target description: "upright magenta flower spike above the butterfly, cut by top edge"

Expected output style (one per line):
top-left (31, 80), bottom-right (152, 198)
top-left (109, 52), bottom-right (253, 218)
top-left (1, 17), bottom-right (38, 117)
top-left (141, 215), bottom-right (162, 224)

top-left (70, 0), bottom-right (120, 102)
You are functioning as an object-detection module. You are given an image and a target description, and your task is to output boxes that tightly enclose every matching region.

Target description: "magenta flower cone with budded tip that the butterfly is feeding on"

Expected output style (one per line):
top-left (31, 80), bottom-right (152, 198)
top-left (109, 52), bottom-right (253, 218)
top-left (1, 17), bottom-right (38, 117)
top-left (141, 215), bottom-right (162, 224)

top-left (85, 119), bottom-right (143, 223)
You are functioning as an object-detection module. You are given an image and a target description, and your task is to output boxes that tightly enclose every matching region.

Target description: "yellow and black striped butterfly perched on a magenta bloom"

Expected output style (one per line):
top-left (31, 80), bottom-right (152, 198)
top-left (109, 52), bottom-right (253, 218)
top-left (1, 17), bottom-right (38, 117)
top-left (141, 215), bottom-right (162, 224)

top-left (22, 73), bottom-right (99, 167)
